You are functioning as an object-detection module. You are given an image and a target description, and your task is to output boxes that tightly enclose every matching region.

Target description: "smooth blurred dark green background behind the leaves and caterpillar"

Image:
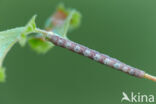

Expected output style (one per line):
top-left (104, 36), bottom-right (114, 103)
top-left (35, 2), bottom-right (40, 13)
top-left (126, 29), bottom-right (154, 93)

top-left (0, 0), bottom-right (156, 104)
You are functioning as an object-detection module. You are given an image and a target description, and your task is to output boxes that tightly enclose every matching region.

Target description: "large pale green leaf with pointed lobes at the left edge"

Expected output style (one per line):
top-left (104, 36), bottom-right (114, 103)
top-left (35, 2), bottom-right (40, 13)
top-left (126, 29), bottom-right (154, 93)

top-left (0, 17), bottom-right (36, 81)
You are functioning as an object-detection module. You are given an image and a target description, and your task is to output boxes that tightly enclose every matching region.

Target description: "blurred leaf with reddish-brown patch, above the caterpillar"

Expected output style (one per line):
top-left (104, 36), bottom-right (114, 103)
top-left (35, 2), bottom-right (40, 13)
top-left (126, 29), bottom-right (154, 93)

top-left (45, 5), bottom-right (81, 37)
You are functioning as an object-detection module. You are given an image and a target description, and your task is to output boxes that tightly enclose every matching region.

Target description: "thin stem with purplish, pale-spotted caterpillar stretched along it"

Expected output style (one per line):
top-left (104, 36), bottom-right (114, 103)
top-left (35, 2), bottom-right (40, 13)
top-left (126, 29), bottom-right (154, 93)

top-left (37, 29), bottom-right (156, 82)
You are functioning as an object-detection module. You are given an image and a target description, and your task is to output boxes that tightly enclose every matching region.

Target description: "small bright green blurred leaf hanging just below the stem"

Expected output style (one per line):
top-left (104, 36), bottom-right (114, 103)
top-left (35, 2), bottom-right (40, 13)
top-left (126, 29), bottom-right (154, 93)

top-left (29, 38), bottom-right (54, 54)
